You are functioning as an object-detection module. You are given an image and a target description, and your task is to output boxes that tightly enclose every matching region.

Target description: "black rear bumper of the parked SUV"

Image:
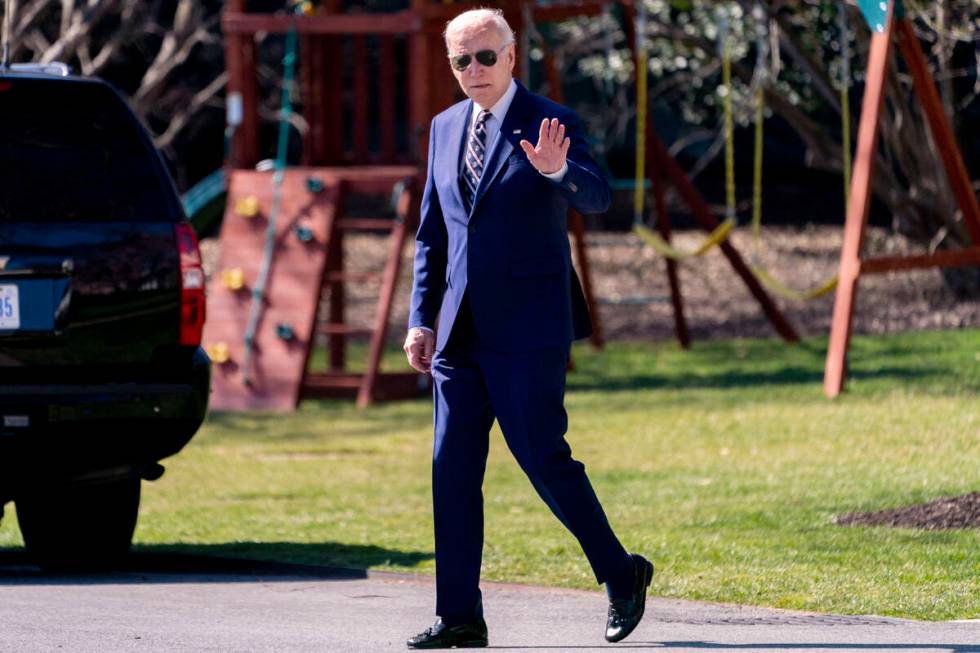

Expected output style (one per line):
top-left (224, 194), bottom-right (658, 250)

top-left (0, 348), bottom-right (211, 492)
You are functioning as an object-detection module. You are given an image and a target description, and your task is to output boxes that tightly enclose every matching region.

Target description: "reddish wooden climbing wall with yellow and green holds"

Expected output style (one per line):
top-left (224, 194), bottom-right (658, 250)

top-left (204, 168), bottom-right (338, 411)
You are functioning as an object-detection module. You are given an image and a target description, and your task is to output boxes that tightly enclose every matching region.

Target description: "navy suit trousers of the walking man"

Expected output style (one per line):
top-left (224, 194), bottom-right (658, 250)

top-left (432, 296), bottom-right (633, 625)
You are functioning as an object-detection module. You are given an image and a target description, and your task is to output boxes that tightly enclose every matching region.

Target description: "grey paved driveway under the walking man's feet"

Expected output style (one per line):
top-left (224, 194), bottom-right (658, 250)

top-left (0, 553), bottom-right (980, 653)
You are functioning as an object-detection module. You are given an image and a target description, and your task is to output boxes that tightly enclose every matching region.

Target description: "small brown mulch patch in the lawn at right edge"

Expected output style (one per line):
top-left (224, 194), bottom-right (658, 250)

top-left (837, 492), bottom-right (980, 530)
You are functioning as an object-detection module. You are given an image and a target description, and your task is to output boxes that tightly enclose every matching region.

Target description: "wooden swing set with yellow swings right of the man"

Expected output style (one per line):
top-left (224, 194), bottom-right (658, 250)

top-left (631, 0), bottom-right (980, 398)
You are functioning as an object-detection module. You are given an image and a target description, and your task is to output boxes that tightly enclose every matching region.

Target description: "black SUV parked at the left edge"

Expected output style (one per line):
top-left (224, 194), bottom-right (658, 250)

top-left (0, 66), bottom-right (211, 568)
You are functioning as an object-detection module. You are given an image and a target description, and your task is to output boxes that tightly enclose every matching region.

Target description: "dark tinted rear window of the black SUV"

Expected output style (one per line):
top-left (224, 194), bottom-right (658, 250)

top-left (0, 77), bottom-right (178, 222)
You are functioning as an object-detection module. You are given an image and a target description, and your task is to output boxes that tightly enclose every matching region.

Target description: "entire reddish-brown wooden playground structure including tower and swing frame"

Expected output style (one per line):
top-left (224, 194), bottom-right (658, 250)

top-left (204, 0), bottom-right (980, 410)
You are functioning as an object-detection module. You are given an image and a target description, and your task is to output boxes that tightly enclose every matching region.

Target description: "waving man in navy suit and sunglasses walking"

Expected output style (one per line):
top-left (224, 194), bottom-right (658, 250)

top-left (405, 9), bottom-right (653, 648)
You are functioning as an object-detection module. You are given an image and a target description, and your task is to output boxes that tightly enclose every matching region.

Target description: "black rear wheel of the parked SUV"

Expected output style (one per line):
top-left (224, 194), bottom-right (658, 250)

top-left (15, 478), bottom-right (140, 571)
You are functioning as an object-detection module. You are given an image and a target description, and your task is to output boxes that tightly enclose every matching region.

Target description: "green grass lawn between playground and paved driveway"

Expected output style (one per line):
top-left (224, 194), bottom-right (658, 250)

top-left (0, 331), bottom-right (980, 619)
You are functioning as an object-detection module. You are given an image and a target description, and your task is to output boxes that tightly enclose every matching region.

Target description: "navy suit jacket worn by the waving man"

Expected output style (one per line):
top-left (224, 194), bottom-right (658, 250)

top-left (408, 83), bottom-right (612, 352)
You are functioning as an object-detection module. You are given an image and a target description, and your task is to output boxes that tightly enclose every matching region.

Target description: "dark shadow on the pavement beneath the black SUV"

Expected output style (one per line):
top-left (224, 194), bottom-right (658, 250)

top-left (0, 542), bottom-right (434, 586)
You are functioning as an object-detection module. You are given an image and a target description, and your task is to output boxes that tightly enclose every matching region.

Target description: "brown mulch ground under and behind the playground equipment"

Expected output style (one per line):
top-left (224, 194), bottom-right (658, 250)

top-left (202, 226), bottom-right (980, 342)
